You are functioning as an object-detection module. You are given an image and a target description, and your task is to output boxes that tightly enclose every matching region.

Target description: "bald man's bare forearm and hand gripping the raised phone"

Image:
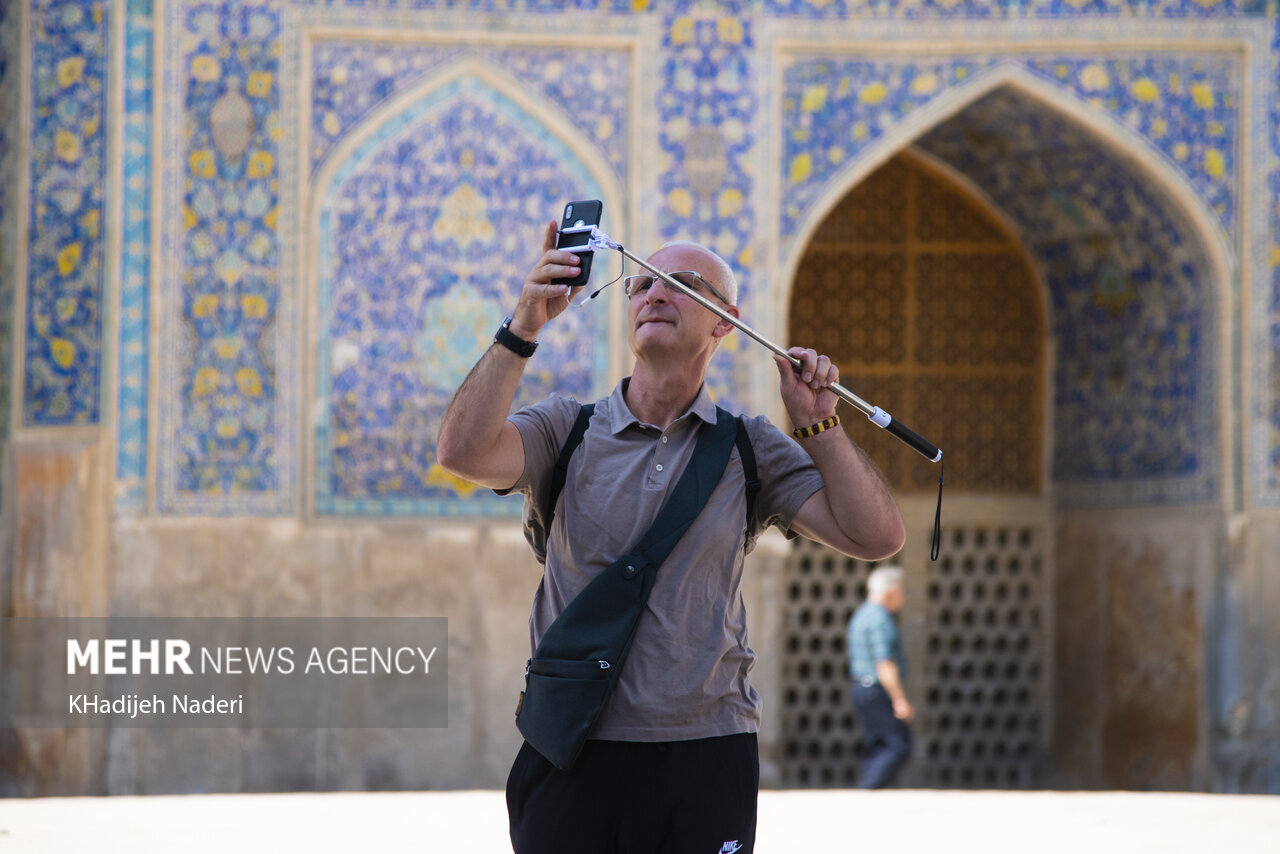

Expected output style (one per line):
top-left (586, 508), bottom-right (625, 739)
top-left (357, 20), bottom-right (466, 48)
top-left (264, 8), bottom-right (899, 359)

top-left (435, 222), bottom-right (579, 489)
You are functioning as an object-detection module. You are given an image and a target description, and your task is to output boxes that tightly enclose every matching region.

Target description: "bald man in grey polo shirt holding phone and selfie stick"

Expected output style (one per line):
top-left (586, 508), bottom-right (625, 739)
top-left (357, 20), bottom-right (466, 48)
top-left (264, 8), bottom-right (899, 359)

top-left (436, 222), bottom-right (905, 854)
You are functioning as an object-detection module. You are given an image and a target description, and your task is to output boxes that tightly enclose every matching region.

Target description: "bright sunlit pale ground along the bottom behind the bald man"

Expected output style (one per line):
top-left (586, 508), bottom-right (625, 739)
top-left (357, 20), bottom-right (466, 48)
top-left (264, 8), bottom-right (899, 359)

top-left (0, 790), bottom-right (1280, 854)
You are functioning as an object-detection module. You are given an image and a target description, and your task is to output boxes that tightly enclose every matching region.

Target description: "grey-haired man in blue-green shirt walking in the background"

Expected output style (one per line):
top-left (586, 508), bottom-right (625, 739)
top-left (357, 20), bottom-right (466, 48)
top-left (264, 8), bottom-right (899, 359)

top-left (849, 566), bottom-right (915, 789)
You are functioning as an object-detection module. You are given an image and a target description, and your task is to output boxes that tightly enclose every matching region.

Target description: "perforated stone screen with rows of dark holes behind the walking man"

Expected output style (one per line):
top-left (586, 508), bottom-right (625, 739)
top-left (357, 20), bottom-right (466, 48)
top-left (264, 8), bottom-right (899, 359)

top-left (781, 525), bottom-right (1047, 789)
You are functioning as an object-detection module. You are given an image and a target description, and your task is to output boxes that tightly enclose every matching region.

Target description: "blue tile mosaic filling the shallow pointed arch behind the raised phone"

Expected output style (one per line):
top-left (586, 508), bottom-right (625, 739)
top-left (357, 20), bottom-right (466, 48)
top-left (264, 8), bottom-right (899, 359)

top-left (316, 78), bottom-right (607, 515)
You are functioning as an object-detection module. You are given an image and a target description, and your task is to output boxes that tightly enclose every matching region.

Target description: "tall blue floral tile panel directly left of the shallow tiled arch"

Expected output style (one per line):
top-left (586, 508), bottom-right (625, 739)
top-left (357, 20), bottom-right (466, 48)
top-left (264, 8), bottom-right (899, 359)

top-left (157, 4), bottom-right (284, 512)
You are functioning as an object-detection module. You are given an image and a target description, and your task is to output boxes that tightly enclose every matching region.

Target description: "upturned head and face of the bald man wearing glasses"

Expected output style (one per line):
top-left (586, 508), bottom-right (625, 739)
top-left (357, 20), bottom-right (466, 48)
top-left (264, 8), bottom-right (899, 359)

top-left (627, 246), bottom-right (737, 362)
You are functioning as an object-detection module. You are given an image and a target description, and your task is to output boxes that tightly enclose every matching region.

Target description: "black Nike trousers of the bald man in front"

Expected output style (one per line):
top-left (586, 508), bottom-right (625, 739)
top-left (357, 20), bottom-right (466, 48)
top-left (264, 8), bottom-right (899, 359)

top-left (507, 732), bottom-right (760, 854)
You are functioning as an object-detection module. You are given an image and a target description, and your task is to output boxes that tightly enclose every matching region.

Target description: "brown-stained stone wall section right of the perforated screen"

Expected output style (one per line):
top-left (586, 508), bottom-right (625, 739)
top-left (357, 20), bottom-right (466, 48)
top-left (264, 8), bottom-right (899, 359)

top-left (1053, 511), bottom-right (1224, 790)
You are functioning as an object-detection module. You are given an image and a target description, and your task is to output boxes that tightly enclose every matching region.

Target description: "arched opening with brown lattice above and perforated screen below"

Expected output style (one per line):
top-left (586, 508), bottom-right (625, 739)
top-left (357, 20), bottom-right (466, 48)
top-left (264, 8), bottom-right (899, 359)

top-left (781, 151), bottom-right (1048, 787)
